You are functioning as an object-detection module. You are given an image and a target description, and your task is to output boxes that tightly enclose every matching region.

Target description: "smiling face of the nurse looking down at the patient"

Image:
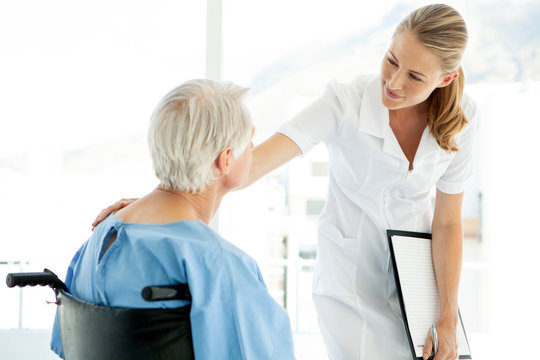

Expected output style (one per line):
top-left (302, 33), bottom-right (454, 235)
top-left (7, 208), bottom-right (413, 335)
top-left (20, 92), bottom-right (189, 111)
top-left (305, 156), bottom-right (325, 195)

top-left (381, 32), bottom-right (446, 110)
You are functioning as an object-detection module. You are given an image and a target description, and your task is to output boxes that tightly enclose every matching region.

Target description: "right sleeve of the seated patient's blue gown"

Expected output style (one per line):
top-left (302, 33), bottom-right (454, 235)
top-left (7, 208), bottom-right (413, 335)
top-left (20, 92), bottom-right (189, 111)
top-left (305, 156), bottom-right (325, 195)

top-left (188, 242), bottom-right (294, 360)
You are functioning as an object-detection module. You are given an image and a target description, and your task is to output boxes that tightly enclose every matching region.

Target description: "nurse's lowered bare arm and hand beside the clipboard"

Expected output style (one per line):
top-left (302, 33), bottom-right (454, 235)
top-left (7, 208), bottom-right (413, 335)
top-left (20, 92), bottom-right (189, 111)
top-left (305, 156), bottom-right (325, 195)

top-left (424, 190), bottom-right (463, 360)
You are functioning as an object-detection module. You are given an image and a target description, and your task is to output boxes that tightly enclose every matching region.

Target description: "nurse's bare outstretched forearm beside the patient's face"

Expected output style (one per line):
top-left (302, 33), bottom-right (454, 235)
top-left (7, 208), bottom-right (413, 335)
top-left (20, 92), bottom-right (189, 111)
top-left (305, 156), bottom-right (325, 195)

top-left (244, 133), bottom-right (302, 187)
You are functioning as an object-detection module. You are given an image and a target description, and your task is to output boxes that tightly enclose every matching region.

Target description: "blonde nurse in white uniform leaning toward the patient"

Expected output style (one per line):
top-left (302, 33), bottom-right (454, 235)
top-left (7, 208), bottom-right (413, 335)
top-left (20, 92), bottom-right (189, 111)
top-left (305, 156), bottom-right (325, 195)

top-left (94, 5), bottom-right (476, 360)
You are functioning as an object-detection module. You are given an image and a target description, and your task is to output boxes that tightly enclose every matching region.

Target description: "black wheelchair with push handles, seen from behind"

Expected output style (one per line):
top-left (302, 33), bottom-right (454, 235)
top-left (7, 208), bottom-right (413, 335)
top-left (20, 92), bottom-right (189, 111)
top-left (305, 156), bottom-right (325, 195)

top-left (6, 269), bottom-right (194, 360)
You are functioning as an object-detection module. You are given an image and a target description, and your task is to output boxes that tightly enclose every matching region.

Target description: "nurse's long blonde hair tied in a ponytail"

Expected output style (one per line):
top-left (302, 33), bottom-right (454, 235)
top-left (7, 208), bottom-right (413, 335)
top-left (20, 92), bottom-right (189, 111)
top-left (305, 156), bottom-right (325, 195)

top-left (394, 4), bottom-right (468, 152)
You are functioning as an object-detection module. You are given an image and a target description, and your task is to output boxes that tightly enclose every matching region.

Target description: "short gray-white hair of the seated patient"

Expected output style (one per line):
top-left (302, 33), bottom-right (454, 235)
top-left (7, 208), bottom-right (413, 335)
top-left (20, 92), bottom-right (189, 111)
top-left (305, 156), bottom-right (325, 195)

top-left (148, 79), bottom-right (253, 193)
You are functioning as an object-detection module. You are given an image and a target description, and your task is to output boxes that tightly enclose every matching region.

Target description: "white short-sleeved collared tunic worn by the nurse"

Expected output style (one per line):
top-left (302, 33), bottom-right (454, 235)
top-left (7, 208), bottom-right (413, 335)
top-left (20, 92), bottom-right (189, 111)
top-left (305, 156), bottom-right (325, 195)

top-left (279, 77), bottom-right (476, 360)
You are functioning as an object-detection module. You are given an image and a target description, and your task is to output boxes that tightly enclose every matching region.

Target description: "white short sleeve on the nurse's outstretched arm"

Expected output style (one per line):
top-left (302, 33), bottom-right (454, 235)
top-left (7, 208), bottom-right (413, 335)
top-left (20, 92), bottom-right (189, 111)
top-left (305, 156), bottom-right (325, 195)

top-left (278, 81), bottom-right (348, 154)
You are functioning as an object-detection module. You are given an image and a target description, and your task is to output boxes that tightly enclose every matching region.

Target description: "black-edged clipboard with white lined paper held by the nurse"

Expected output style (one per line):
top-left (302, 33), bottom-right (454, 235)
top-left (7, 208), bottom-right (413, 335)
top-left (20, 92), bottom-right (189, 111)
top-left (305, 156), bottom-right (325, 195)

top-left (386, 230), bottom-right (472, 360)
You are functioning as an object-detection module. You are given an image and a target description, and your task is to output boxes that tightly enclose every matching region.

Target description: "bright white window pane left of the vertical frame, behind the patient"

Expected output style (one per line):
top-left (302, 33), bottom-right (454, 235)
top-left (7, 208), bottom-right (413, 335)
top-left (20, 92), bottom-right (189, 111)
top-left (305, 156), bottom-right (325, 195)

top-left (0, 0), bottom-right (206, 329)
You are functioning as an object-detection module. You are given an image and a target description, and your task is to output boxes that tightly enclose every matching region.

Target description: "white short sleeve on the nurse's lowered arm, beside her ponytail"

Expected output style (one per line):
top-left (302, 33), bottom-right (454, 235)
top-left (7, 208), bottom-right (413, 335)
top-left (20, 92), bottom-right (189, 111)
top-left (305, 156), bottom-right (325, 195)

top-left (437, 96), bottom-right (478, 194)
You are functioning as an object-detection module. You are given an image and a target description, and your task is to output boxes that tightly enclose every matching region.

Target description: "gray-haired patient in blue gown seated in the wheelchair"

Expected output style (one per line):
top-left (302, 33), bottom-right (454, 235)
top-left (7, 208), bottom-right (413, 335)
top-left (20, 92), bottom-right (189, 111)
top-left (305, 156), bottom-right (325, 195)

top-left (51, 80), bottom-right (294, 359)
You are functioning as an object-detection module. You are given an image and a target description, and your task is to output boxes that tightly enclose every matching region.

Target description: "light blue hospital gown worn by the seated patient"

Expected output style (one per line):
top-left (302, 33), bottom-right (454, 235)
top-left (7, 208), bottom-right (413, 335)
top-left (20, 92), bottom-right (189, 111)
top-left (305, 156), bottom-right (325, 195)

top-left (51, 215), bottom-right (294, 359)
